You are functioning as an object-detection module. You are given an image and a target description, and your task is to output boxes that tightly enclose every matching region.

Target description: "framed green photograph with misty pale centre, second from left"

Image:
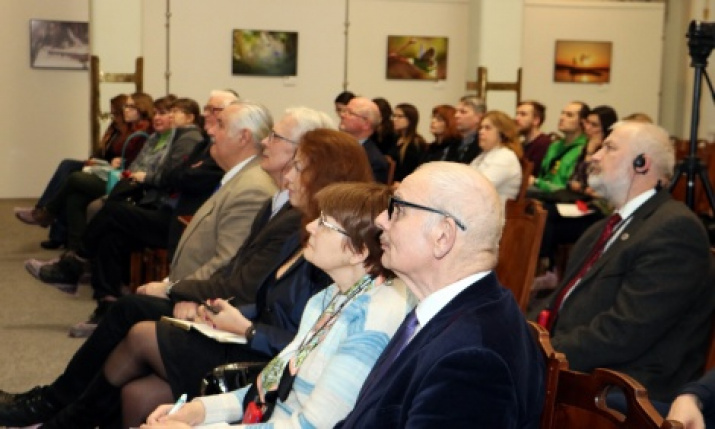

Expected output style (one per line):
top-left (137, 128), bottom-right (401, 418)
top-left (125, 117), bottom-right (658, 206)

top-left (232, 30), bottom-right (298, 76)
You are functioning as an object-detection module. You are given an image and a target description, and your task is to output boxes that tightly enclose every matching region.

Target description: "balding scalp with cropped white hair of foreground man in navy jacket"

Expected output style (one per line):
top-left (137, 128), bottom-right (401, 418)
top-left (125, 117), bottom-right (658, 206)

top-left (417, 161), bottom-right (504, 267)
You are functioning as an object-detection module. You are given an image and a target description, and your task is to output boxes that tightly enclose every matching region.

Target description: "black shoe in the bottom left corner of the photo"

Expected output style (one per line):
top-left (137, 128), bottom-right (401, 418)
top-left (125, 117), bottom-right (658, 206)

top-left (0, 386), bottom-right (63, 427)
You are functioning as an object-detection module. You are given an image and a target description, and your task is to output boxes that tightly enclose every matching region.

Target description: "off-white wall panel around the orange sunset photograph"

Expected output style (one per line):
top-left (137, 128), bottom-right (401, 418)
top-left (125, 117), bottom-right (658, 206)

top-left (522, 0), bottom-right (664, 132)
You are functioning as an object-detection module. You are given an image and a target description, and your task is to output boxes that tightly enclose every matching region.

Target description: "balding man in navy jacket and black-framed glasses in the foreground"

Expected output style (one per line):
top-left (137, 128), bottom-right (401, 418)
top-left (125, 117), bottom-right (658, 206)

top-left (337, 162), bottom-right (545, 428)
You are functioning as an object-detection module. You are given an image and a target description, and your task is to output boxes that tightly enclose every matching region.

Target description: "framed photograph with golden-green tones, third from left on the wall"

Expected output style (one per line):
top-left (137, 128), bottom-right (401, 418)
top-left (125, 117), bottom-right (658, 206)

top-left (386, 36), bottom-right (449, 80)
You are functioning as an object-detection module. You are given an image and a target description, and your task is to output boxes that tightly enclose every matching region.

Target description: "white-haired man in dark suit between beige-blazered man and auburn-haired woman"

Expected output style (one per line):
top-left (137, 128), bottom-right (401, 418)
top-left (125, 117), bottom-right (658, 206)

top-left (0, 108), bottom-right (333, 426)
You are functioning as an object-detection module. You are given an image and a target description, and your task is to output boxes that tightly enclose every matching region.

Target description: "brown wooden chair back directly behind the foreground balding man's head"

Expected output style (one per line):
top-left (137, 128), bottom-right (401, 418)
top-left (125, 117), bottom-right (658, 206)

top-left (495, 199), bottom-right (547, 311)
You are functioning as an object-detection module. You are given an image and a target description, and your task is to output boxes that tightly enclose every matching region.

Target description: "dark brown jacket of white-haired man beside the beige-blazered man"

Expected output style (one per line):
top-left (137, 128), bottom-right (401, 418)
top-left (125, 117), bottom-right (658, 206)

top-left (171, 199), bottom-right (301, 306)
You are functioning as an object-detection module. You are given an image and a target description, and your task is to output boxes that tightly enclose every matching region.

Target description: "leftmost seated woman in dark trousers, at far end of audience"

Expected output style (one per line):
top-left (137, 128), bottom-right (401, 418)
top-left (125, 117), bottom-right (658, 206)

top-left (15, 94), bottom-right (129, 249)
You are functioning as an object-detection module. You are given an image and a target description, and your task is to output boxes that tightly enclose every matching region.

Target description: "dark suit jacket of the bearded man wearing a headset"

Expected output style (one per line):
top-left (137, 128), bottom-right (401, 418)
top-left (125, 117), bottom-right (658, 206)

top-left (552, 190), bottom-right (715, 401)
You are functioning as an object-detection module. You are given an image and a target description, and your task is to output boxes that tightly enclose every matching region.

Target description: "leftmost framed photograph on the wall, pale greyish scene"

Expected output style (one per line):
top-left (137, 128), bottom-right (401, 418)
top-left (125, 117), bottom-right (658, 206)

top-left (30, 19), bottom-right (89, 70)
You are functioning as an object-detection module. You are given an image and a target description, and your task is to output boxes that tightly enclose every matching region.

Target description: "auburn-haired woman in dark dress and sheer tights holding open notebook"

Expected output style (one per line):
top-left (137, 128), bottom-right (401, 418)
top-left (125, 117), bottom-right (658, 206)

top-left (30, 129), bottom-right (388, 427)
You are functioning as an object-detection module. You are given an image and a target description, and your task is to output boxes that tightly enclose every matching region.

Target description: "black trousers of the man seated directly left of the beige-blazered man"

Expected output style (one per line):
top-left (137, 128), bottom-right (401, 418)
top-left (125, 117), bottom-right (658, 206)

top-left (84, 200), bottom-right (173, 300)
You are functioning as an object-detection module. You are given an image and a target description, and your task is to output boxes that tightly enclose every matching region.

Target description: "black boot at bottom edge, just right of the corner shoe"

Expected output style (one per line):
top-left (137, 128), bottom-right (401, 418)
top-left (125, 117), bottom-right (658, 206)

top-left (40, 371), bottom-right (120, 429)
